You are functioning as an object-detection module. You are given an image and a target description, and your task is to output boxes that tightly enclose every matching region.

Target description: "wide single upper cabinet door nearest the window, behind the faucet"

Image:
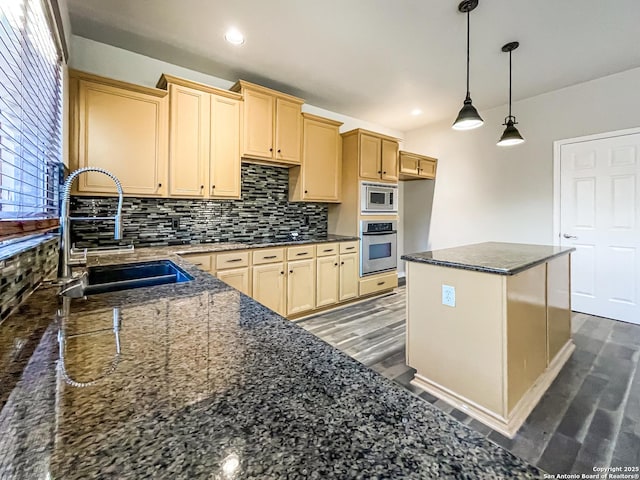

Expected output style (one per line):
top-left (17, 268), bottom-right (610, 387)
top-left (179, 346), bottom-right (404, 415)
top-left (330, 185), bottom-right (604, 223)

top-left (77, 80), bottom-right (168, 196)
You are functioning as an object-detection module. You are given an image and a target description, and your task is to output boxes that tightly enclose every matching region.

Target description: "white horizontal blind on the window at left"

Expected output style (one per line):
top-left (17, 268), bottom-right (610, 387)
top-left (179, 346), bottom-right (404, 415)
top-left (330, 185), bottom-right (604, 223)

top-left (0, 0), bottom-right (62, 232)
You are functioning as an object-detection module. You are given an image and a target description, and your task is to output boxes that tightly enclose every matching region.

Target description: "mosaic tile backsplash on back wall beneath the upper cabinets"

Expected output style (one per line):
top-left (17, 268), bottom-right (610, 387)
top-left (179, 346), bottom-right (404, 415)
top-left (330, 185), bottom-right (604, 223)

top-left (71, 163), bottom-right (327, 247)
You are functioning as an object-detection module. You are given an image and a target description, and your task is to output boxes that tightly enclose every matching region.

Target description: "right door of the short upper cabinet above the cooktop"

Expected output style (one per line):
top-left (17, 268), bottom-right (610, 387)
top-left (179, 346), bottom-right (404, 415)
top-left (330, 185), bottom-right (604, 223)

top-left (274, 98), bottom-right (302, 163)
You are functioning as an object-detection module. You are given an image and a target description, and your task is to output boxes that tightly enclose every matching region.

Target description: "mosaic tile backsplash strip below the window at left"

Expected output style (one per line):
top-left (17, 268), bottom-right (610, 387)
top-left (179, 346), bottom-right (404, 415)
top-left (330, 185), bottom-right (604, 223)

top-left (0, 235), bottom-right (58, 321)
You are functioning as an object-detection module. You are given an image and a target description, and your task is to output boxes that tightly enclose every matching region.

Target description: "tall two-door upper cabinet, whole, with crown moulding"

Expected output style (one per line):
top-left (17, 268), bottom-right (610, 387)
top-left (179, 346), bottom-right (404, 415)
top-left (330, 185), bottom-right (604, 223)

top-left (158, 75), bottom-right (241, 198)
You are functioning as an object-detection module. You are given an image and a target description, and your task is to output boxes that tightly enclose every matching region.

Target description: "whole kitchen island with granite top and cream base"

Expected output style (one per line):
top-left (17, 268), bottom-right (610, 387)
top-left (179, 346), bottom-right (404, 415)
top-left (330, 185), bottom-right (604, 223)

top-left (402, 242), bottom-right (575, 437)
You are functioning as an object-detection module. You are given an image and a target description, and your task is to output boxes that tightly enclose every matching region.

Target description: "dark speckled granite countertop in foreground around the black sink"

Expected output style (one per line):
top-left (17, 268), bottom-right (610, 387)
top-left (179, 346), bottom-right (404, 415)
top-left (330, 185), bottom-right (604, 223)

top-left (0, 247), bottom-right (542, 479)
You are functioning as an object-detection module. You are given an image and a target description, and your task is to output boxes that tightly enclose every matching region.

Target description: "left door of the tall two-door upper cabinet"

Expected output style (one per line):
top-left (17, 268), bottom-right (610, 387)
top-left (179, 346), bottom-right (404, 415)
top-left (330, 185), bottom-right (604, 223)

top-left (169, 85), bottom-right (210, 198)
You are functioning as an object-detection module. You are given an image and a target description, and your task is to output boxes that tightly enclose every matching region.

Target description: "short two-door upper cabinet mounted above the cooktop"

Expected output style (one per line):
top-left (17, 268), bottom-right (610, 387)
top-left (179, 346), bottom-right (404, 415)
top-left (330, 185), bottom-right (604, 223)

top-left (231, 80), bottom-right (304, 165)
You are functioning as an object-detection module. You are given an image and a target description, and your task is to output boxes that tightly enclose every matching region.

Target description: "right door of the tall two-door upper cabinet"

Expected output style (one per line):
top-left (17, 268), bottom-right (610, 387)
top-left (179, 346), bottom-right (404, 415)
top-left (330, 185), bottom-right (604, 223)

top-left (209, 95), bottom-right (240, 198)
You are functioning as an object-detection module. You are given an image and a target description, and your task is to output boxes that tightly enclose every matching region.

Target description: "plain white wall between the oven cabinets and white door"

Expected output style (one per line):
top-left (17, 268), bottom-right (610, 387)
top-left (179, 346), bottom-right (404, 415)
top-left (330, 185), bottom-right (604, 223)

top-left (403, 68), bottom-right (640, 253)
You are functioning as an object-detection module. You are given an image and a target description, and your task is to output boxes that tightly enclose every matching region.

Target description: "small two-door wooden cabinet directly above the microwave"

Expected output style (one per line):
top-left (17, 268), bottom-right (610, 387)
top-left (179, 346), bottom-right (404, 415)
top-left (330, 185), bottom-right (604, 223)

top-left (342, 129), bottom-right (398, 183)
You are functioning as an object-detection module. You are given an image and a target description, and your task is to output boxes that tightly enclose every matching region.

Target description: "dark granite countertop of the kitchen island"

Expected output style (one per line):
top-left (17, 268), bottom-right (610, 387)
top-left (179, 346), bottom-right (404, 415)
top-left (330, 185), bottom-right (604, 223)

top-left (401, 242), bottom-right (575, 275)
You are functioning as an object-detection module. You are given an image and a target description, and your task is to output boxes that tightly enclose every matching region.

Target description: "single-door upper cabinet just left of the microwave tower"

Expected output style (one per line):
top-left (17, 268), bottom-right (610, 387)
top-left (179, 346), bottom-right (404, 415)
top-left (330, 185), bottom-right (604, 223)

top-left (289, 113), bottom-right (342, 203)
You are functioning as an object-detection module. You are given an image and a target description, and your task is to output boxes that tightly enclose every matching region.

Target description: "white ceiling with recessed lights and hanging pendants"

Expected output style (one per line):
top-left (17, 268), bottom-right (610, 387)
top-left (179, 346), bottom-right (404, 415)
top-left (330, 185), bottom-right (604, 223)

top-left (67, 0), bottom-right (640, 131)
